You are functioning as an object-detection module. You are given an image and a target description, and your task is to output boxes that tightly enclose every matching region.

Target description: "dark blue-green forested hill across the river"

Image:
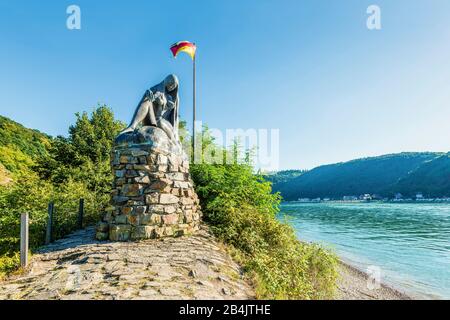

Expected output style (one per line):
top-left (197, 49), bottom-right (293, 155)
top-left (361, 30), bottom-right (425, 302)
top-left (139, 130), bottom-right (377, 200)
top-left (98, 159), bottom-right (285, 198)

top-left (270, 152), bottom-right (450, 200)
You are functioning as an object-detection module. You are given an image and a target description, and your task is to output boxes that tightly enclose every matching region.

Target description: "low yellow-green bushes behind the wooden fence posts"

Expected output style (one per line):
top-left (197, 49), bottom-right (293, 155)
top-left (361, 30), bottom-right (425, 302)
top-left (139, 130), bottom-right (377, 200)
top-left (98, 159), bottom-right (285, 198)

top-left (0, 175), bottom-right (109, 277)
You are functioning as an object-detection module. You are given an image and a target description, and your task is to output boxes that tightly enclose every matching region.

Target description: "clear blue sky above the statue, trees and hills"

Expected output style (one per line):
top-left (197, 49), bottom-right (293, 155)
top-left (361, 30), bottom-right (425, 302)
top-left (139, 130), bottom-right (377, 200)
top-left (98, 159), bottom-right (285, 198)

top-left (0, 0), bottom-right (450, 169)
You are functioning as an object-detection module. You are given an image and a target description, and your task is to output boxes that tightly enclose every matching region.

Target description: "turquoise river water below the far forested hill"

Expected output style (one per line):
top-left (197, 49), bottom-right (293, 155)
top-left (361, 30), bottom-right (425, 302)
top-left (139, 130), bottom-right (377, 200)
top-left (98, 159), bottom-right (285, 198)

top-left (280, 202), bottom-right (450, 299)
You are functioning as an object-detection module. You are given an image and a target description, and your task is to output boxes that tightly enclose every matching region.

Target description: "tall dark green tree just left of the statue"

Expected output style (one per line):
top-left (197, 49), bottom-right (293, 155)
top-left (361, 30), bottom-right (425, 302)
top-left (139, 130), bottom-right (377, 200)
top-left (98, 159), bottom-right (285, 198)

top-left (36, 105), bottom-right (125, 192)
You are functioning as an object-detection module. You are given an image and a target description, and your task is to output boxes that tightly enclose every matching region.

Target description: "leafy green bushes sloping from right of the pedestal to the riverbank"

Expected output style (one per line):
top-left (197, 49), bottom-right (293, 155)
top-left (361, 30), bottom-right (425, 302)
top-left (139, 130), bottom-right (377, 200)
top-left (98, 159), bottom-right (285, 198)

top-left (191, 130), bottom-right (337, 299)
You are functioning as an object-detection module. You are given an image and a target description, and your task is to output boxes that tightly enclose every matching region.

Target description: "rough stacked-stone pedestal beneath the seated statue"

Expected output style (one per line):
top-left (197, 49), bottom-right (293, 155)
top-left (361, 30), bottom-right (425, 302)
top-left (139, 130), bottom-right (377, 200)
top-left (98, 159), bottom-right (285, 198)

top-left (97, 127), bottom-right (201, 241)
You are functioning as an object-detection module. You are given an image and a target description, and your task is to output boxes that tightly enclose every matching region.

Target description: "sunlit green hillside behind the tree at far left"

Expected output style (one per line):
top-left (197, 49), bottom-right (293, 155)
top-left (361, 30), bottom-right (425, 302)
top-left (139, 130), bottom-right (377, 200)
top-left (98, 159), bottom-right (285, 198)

top-left (0, 116), bottom-right (50, 183)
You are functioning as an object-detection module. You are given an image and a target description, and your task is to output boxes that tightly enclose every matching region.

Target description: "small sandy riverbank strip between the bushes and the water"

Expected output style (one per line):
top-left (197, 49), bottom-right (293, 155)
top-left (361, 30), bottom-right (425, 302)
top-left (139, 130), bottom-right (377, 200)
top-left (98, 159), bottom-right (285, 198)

top-left (337, 262), bottom-right (413, 300)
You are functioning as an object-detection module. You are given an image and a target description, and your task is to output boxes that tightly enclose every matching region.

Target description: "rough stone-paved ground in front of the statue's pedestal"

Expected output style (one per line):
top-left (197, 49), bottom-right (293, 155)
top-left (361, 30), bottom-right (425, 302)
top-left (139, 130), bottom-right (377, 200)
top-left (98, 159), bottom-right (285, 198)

top-left (0, 228), bottom-right (254, 300)
